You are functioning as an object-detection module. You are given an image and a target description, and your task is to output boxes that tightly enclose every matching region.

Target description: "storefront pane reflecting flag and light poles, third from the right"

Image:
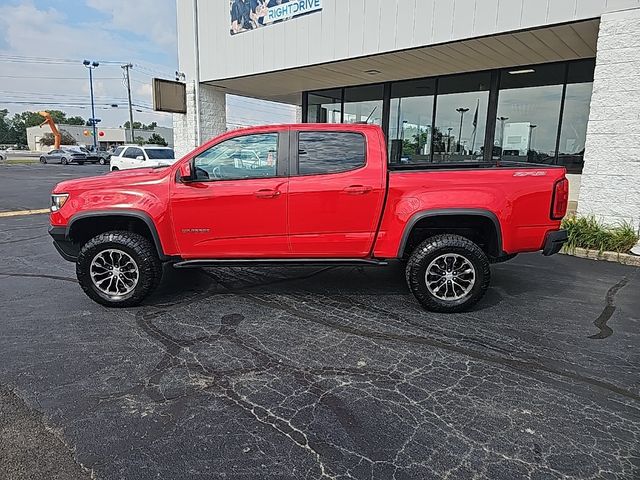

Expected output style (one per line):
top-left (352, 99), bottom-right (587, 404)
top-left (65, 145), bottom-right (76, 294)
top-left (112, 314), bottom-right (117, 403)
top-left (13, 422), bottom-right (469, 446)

top-left (433, 72), bottom-right (491, 163)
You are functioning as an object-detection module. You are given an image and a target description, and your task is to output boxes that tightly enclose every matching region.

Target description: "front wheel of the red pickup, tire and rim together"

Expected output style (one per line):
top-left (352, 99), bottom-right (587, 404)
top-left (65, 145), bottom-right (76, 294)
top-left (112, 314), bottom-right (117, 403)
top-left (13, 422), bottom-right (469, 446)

top-left (76, 231), bottom-right (162, 307)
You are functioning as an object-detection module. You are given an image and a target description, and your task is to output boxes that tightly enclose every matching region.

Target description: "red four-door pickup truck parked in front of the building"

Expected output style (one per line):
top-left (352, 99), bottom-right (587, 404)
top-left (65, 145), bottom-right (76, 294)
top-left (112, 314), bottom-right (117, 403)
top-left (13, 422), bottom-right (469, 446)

top-left (49, 124), bottom-right (568, 312)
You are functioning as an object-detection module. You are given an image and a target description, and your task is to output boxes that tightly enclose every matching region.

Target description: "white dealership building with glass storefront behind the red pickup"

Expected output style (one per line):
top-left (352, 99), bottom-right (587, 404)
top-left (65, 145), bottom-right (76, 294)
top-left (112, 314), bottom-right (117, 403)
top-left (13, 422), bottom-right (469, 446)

top-left (174, 0), bottom-right (640, 226)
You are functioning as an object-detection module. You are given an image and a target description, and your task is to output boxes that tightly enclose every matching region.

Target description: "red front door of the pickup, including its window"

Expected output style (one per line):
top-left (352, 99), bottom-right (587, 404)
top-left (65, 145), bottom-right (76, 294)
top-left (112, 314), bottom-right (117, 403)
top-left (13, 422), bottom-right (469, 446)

top-left (171, 131), bottom-right (290, 259)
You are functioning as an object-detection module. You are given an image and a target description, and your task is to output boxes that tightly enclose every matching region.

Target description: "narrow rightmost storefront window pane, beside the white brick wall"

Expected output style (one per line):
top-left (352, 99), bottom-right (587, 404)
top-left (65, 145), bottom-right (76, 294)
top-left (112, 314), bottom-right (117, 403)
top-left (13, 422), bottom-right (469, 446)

top-left (558, 60), bottom-right (595, 173)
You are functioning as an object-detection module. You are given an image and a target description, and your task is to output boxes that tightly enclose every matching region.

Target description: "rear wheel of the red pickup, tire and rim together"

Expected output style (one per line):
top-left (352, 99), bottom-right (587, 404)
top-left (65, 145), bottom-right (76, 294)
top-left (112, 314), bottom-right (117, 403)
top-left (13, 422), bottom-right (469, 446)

top-left (406, 235), bottom-right (491, 313)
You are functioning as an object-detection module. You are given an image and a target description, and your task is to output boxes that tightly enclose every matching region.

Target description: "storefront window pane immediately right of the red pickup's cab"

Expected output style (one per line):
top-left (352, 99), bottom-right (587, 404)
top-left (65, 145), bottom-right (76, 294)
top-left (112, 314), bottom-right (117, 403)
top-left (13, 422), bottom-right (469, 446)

top-left (388, 79), bottom-right (436, 164)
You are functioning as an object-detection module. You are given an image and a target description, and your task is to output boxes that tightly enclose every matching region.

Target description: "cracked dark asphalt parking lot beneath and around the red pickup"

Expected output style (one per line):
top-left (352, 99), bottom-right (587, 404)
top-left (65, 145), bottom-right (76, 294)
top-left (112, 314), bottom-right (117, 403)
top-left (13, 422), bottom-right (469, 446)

top-left (0, 165), bottom-right (640, 480)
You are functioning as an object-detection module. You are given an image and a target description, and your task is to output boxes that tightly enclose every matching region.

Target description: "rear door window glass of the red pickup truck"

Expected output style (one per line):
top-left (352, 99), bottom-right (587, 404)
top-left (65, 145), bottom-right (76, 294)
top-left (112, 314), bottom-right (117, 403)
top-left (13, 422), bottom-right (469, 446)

top-left (298, 132), bottom-right (365, 175)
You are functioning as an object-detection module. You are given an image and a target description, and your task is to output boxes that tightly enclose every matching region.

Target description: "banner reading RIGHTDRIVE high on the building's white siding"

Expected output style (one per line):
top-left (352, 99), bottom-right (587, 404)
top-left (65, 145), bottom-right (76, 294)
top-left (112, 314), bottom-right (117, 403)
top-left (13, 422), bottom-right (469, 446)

top-left (229, 0), bottom-right (322, 35)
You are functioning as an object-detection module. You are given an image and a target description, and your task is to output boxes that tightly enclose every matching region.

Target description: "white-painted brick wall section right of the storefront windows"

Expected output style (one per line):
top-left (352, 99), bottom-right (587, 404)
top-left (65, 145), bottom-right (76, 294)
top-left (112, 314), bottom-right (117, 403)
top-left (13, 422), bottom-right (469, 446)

top-left (578, 9), bottom-right (640, 231)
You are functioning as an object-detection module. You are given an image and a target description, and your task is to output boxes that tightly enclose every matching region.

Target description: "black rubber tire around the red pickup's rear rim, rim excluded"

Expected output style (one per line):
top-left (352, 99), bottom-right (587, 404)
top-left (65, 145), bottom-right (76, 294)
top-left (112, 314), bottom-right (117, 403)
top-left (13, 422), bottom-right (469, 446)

top-left (406, 234), bottom-right (491, 313)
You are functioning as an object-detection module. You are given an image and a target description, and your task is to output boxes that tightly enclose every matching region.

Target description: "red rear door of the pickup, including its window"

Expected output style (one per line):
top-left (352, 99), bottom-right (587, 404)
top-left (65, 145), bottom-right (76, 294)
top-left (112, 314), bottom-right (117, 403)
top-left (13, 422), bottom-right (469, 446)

top-left (289, 130), bottom-right (386, 258)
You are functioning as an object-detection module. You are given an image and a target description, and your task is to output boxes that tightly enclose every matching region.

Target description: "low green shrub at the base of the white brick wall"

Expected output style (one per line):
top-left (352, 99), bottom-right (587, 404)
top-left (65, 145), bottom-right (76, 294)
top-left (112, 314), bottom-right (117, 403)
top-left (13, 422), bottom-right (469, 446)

top-left (562, 216), bottom-right (640, 253)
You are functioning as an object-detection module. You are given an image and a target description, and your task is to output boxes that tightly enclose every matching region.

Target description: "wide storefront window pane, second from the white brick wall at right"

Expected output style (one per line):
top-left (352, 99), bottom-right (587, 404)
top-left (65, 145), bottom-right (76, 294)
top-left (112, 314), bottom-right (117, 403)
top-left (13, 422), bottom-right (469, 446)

top-left (494, 64), bottom-right (565, 164)
